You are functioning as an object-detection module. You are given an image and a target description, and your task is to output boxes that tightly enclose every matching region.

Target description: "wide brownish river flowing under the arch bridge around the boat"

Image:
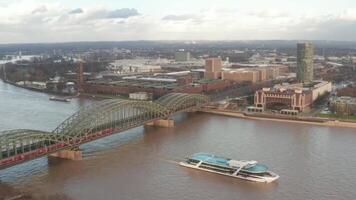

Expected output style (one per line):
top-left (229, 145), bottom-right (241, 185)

top-left (0, 81), bottom-right (356, 200)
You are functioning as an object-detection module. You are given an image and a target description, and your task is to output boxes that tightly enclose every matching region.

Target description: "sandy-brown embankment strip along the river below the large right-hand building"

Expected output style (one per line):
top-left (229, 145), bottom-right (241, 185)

top-left (202, 109), bottom-right (356, 128)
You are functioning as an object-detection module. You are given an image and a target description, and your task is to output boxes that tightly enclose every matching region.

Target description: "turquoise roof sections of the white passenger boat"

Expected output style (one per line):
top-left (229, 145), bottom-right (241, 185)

top-left (190, 153), bottom-right (268, 173)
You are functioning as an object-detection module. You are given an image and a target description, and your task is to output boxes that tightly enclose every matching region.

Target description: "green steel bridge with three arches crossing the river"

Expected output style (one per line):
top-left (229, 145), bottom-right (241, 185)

top-left (0, 93), bottom-right (209, 169)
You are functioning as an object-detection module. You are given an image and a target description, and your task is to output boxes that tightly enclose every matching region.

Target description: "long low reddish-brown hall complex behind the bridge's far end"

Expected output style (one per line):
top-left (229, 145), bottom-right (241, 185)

top-left (83, 67), bottom-right (232, 98)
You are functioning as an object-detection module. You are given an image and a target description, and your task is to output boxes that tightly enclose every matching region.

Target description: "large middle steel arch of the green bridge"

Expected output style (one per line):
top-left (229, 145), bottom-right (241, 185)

top-left (53, 99), bottom-right (169, 139)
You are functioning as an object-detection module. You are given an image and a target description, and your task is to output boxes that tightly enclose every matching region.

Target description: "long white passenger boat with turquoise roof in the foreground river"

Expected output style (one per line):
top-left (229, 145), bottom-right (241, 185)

top-left (179, 153), bottom-right (279, 183)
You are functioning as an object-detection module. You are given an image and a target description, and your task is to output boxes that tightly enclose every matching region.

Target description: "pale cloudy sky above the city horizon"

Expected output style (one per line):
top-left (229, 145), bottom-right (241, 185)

top-left (0, 0), bottom-right (356, 43)
